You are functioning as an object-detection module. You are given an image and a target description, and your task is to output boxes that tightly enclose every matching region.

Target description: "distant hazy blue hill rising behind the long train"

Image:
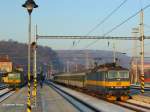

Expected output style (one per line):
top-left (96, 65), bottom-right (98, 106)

top-left (55, 50), bottom-right (130, 71)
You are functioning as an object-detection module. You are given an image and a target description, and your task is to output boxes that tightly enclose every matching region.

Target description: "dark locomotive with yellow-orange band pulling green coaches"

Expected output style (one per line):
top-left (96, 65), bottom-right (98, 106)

top-left (86, 63), bottom-right (130, 100)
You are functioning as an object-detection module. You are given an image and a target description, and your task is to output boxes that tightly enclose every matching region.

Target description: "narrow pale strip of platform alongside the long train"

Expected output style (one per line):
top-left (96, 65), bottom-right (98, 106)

top-left (51, 82), bottom-right (135, 112)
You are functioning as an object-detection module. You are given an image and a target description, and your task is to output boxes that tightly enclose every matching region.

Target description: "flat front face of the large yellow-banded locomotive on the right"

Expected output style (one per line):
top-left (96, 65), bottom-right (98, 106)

top-left (106, 69), bottom-right (130, 100)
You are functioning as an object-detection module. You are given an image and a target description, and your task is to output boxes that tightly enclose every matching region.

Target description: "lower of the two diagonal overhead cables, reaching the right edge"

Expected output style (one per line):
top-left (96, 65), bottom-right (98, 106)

top-left (82, 4), bottom-right (150, 48)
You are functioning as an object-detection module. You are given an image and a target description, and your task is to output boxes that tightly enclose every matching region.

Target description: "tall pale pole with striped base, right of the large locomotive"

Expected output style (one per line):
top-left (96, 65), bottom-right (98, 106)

top-left (140, 9), bottom-right (144, 94)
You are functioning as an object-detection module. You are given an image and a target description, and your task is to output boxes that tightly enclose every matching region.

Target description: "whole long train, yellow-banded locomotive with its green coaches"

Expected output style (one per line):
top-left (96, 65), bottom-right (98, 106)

top-left (53, 63), bottom-right (130, 101)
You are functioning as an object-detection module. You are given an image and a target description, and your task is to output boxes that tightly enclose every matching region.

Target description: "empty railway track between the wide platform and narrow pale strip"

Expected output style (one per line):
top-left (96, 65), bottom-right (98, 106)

top-left (47, 82), bottom-right (101, 112)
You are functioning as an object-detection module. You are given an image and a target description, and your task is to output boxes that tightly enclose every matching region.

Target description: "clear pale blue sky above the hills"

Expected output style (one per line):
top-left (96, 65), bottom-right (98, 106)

top-left (0, 0), bottom-right (150, 55)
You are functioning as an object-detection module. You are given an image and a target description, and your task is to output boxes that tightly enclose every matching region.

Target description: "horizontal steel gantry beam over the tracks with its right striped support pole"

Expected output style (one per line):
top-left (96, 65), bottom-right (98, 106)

top-left (35, 30), bottom-right (150, 93)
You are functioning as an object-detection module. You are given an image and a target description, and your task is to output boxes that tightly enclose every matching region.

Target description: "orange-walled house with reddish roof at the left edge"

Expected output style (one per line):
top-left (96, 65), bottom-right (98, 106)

top-left (0, 55), bottom-right (12, 73)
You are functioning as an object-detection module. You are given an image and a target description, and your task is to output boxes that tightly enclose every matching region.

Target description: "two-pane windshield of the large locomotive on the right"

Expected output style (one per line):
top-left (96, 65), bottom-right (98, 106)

top-left (108, 71), bottom-right (129, 79)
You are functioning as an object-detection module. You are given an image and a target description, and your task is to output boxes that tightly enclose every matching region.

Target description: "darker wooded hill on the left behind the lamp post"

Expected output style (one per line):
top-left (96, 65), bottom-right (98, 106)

top-left (0, 40), bottom-right (62, 74)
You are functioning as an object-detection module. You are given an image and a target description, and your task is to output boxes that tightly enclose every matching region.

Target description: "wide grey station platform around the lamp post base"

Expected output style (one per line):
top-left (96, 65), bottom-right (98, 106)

top-left (0, 85), bottom-right (78, 112)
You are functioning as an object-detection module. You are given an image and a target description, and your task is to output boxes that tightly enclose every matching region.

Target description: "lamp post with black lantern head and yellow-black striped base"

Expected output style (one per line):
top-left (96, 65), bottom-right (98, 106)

top-left (22, 0), bottom-right (38, 112)
